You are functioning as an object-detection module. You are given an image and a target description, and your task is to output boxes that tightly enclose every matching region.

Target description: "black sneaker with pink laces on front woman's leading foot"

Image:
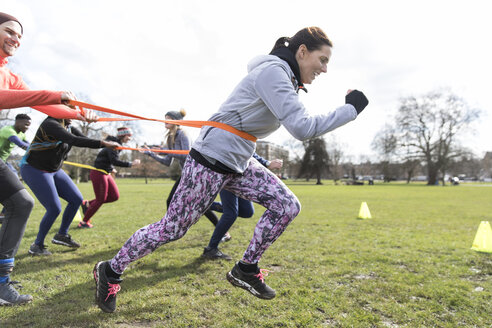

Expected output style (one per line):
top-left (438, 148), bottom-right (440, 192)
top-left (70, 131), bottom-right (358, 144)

top-left (226, 263), bottom-right (275, 300)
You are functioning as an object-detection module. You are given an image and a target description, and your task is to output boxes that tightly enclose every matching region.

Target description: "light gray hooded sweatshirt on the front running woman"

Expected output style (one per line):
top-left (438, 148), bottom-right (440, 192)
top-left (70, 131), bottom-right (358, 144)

top-left (192, 55), bottom-right (357, 173)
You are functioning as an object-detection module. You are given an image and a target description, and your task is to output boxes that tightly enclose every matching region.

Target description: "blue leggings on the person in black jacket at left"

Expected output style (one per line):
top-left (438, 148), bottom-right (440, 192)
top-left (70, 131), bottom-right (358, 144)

top-left (21, 164), bottom-right (83, 246)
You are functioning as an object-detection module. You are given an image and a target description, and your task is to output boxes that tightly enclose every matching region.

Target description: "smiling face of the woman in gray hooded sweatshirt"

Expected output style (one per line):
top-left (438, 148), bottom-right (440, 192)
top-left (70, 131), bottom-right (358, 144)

top-left (296, 44), bottom-right (331, 84)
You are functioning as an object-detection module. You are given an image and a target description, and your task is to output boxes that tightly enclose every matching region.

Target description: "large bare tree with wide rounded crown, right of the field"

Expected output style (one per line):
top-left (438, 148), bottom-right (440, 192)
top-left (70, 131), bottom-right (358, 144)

top-left (382, 90), bottom-right (480, 185)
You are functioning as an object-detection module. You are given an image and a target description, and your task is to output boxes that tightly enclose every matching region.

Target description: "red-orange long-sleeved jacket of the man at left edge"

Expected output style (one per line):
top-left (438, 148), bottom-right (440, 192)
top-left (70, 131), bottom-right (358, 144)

top-left (0, 57), bottom-right (77, 119)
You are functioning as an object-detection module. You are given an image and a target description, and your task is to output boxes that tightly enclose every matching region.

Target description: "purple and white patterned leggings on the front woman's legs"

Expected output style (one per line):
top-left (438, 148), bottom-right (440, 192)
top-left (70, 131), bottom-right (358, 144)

top-left (111, 156), bottom-right (301, 273)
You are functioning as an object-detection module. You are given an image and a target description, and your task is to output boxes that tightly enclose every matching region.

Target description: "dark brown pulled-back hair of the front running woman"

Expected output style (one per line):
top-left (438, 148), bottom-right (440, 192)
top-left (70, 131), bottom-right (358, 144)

top-left (272, 26), bottom-right (333, 54)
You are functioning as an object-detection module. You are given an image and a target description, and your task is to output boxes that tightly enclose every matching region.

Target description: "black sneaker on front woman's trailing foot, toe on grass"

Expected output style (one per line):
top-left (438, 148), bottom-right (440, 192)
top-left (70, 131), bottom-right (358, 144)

top-left (92, 261), bottom-right (123, 313)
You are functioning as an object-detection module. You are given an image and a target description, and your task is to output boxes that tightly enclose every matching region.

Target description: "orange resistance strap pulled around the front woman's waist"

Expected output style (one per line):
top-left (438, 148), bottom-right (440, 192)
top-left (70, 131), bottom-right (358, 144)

top-left (68, 100), bottom-right (257, 142)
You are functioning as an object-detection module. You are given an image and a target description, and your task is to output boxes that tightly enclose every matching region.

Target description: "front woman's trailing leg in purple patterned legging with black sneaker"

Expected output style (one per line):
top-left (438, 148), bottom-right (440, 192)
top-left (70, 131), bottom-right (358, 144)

top-left (94, 157), bottom-right (225, 312)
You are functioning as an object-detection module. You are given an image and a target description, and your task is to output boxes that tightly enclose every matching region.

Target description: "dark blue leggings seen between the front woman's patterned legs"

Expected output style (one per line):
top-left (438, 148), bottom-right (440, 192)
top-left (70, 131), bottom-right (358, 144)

top-left (208, 189), bottom-right (255, 248)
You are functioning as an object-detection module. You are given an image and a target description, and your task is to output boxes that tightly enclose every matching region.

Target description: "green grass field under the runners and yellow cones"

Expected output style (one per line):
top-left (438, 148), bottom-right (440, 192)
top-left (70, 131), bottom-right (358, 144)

top-left (0, 179), bottom-right (492, 327)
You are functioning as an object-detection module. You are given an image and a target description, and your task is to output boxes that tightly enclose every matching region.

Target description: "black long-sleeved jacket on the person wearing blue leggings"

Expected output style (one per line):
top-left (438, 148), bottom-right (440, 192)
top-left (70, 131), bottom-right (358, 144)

top-left (25, 117), bottom-right (103, 172)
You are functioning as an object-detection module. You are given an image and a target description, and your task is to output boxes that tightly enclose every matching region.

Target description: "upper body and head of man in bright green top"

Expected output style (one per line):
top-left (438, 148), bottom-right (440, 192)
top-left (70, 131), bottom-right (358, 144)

top-left (0, 114), bottom-right (31, 162)
